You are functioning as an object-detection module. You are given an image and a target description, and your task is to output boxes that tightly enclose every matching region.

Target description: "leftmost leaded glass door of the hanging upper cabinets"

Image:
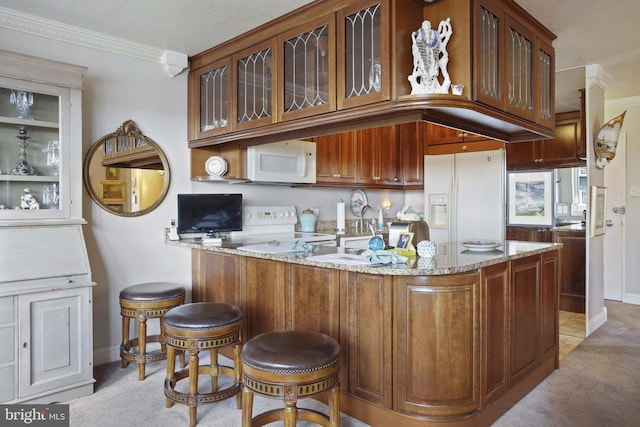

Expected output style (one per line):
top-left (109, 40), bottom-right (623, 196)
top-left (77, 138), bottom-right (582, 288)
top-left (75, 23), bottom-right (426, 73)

top-left (189, 58), bottom-right (231, 139)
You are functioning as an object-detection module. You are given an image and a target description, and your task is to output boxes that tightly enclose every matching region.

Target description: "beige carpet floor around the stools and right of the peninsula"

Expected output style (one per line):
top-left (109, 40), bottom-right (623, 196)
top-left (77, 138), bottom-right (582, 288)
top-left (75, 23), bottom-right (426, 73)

top-left (69, 302), bottom-right (640, 427)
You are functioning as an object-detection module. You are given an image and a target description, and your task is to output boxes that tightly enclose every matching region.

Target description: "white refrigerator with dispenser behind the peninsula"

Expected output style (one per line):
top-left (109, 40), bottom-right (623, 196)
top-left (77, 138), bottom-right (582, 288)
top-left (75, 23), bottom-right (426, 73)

top-left (424, 149), bottom-right (506, 243)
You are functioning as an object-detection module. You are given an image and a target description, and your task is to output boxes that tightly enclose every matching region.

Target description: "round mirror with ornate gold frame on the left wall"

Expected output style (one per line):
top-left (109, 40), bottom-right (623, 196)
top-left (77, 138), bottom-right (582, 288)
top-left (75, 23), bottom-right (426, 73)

top-left (84, 120), bottom-right (171, 216)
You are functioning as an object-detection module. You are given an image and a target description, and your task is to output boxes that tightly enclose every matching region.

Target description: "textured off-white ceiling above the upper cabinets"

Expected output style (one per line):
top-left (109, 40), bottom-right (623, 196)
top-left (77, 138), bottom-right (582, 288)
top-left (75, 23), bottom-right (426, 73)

top-left (0, 0), bottom-right (640, 99)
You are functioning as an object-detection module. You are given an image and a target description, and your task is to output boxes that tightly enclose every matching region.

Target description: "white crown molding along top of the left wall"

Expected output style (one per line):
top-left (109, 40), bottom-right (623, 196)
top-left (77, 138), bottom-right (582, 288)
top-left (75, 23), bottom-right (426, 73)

top-left (0, 7), bottom-right (188, 77)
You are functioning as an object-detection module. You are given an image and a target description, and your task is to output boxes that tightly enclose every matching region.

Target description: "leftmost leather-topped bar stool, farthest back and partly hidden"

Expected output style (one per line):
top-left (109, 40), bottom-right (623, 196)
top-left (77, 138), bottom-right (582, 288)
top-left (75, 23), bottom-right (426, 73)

top-left (120, 282), bottom-right (185, 380)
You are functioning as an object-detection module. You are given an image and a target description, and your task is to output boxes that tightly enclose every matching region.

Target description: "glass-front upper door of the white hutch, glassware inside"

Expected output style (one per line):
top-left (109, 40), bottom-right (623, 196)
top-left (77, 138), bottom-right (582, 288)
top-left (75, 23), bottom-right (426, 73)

top-left (0, 77), bottom-right (72, 220)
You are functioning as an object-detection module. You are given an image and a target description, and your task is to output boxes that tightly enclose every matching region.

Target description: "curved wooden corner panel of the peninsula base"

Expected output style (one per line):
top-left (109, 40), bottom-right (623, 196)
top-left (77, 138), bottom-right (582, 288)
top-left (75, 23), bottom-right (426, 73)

top-left (393, 272), bottom-right (480, 417)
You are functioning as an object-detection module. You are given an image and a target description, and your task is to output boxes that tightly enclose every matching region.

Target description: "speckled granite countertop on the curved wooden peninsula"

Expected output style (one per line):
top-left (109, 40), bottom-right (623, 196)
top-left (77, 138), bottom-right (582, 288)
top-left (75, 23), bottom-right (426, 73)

top-left (165, 239), bottom-right (562, 276)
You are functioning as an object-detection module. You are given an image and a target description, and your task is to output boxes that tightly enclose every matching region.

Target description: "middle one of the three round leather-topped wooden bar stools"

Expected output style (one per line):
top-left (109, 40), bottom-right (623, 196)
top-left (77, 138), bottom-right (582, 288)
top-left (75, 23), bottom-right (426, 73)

top-left (163, 302), bottom-right (242, 427)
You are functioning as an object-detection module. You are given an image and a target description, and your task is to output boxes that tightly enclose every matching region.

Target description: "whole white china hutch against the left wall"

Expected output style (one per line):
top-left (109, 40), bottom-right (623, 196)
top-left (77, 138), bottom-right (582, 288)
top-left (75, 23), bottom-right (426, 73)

top-left (0, 51), bottom-right (95, 403)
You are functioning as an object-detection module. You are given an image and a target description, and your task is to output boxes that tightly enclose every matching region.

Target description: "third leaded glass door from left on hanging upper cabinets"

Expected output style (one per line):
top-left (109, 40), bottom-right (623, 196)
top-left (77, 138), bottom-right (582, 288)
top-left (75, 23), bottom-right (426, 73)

top-left (278, 15), bottom-right (336, 120)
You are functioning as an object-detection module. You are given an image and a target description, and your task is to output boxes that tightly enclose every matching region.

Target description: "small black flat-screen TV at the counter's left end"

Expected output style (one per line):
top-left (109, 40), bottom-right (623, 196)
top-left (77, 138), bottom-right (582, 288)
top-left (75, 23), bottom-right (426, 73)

top-left (178, 194), bottom-right (242, 235)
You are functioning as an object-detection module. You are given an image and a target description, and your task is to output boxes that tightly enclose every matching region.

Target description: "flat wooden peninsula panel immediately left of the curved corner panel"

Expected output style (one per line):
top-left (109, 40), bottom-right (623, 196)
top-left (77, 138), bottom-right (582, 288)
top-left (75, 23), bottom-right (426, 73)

top-left (340, 272), bottom-right (393, 408)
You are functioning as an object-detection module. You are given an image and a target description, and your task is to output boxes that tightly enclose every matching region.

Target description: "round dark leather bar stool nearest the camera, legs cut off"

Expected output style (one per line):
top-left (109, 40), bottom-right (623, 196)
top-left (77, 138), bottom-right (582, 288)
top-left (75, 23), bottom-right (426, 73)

top-left (240, 331), bottom-right (340, 427)
